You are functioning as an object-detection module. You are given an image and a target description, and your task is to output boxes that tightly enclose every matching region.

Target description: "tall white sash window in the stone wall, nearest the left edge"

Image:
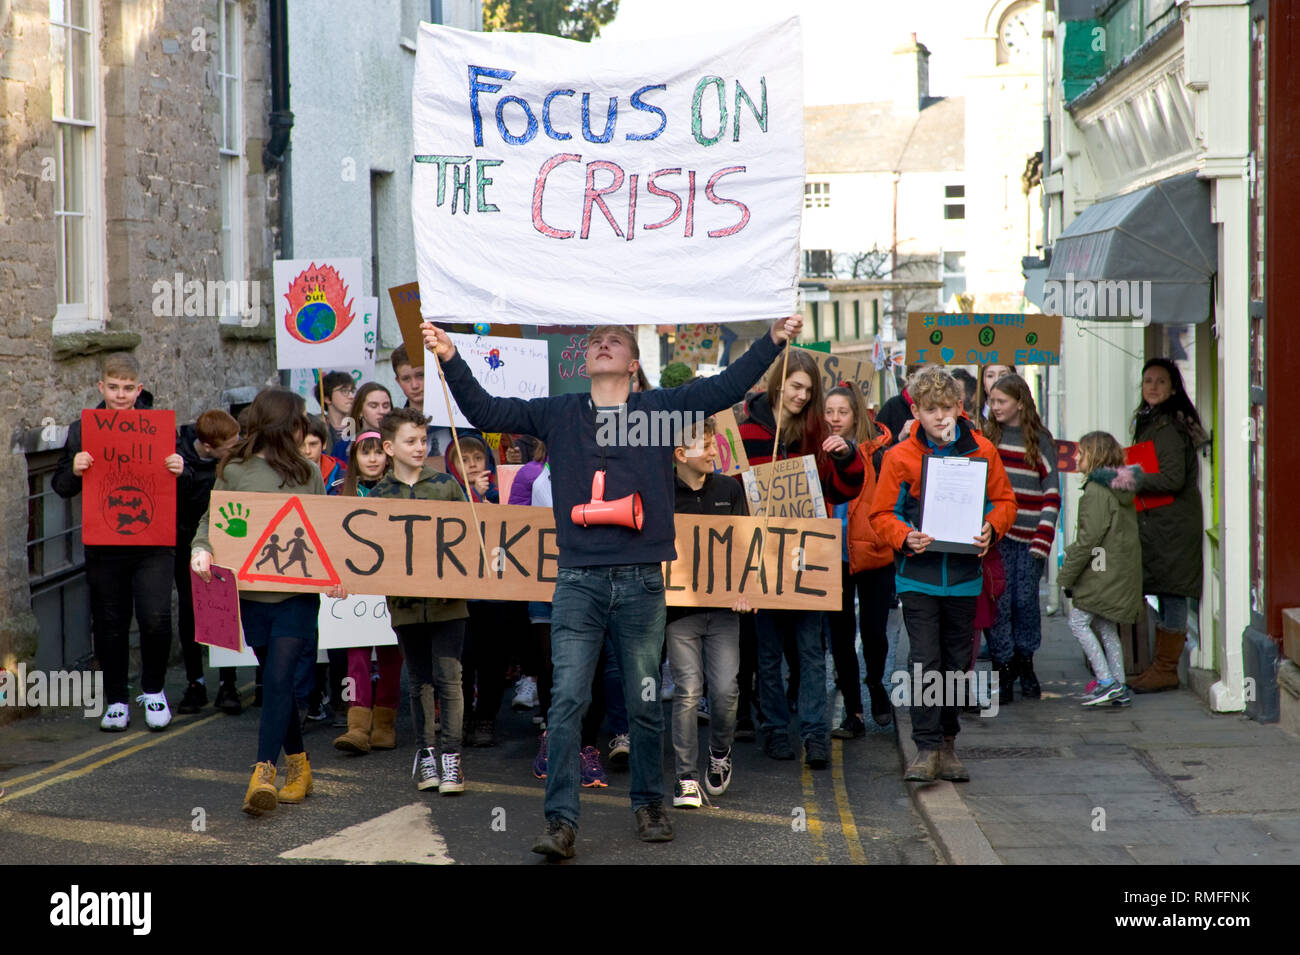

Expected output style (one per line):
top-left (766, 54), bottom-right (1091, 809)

top-left (49, 0), bottom-right (108, 335)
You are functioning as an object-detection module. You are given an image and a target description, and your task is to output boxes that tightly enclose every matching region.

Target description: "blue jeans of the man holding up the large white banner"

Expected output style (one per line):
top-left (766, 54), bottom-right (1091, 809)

top-left (545, 564), bottom-right (664, 828)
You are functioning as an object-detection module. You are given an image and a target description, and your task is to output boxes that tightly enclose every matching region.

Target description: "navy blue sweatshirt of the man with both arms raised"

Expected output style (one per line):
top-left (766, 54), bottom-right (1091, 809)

top-left (443, 335), bottom-right (784, 568)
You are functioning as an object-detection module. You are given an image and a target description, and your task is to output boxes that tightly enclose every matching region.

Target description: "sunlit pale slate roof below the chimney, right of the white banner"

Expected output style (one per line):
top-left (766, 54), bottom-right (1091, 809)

top-left (803, 96), bottom-right (966, 175)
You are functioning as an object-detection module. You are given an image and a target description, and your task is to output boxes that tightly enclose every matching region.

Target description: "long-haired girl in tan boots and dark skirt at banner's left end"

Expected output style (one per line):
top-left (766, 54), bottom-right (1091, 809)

top-left (190, 388), bottom-right (347, 816)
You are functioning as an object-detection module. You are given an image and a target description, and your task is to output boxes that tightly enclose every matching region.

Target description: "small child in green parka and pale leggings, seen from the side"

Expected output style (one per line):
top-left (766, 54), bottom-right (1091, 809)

top-left (1057, 431), bottom-right (1141, 707)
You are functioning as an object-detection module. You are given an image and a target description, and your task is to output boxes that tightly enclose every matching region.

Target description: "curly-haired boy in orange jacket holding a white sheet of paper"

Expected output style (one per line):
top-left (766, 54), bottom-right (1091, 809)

top-left (871, 365), bottom-right (1015, 782)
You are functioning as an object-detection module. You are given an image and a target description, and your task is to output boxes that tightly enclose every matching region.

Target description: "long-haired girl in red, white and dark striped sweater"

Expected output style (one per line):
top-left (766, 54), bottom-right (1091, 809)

top-left (984, 374), bottom-right (1061, 703)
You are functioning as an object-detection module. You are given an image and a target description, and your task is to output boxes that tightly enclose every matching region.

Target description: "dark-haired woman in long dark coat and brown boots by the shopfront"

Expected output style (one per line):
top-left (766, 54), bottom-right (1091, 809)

top-left (1128, 359), bottom-right (1209, 693)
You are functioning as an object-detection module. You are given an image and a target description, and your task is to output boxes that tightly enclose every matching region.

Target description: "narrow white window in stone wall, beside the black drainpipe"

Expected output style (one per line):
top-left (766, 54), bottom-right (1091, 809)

top-left (217, 0), bottom-right (244, 325)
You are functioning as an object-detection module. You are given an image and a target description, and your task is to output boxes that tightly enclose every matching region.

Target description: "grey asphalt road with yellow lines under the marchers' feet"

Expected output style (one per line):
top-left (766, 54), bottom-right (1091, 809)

top-left (0, 669), bottom-right (936, 865)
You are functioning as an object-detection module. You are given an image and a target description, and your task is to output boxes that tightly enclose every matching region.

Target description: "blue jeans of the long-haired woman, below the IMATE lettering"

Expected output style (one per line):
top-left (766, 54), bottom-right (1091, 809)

top-left (754, 611), bottom-right (829, 739)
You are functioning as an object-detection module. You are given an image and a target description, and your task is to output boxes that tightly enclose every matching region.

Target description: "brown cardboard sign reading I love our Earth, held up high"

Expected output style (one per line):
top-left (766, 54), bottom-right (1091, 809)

top-left (907, 312), bottom-right (1061, 366)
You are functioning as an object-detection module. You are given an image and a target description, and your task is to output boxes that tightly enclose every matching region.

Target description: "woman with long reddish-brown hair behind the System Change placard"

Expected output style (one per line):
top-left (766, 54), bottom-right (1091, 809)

top-left (740, 348), bottom-right (863, 769)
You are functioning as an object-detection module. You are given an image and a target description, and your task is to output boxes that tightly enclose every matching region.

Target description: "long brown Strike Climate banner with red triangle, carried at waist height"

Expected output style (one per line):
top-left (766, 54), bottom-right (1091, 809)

top-left (211, 490), bottom-right (840, 609)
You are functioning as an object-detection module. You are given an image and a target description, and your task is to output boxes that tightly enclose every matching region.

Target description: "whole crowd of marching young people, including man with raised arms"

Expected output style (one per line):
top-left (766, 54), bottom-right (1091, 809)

top-left (55, 332), bottom-right (1175, 858)
